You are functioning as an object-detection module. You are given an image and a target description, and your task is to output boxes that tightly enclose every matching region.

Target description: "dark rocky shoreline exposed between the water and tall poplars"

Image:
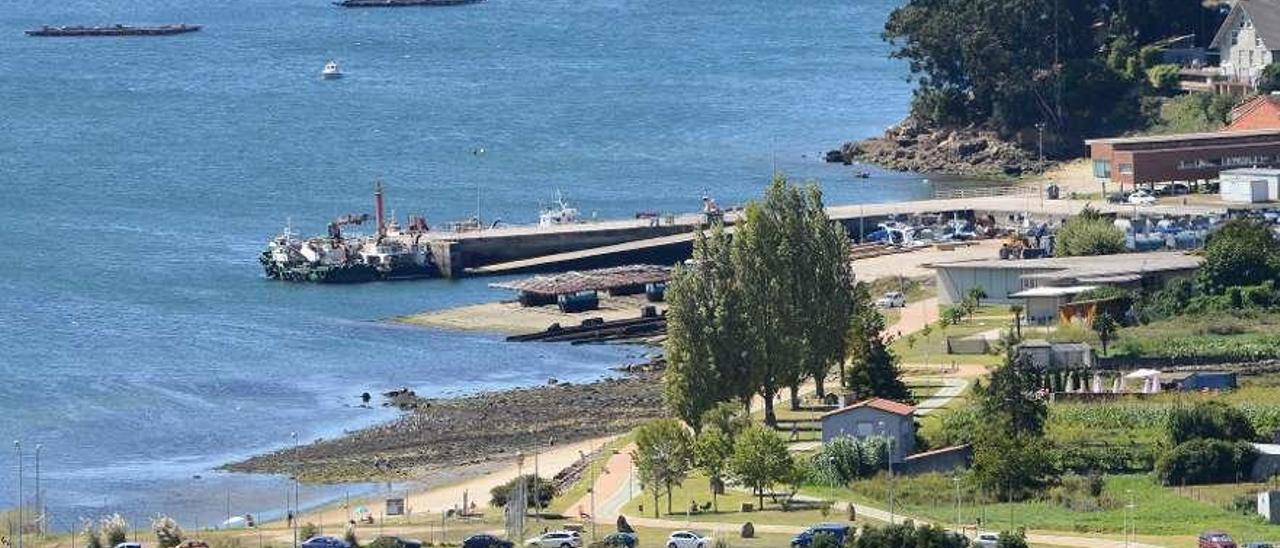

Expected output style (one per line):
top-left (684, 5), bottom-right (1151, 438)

top-left (223, 371), bottom-right (663, 483)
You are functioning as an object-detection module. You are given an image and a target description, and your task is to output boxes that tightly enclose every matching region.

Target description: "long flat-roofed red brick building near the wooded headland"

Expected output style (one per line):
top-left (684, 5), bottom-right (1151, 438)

top-left (1084, 128), bottom-right (1280, 187)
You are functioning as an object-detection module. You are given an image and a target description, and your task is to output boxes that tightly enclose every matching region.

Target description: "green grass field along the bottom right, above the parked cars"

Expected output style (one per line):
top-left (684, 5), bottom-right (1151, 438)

top-left (813, 475), bottom-right (1280, 544)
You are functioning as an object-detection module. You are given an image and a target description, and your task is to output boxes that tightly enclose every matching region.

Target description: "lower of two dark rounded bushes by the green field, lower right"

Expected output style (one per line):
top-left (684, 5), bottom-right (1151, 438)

top-left (1156, 439), bottom-right (1258, 485)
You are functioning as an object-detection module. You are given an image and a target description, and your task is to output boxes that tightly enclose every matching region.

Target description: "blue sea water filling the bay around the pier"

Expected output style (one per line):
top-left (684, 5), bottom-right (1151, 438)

top-left (0, 0), bottom-right (933, 529)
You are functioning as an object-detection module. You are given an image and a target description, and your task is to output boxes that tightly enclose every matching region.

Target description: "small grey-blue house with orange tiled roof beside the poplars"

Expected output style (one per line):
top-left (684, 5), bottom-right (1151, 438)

top-left (822, 398), bottom-right (915, 463)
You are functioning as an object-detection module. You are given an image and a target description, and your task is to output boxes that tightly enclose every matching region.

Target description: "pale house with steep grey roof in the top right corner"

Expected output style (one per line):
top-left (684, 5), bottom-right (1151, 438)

top-left (1210, 0), bottom-right (1280, 87)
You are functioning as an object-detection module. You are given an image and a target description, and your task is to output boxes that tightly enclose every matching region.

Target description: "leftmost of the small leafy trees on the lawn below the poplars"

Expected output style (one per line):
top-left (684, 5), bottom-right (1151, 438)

top-left (631, 419), bottom-right (692, 517)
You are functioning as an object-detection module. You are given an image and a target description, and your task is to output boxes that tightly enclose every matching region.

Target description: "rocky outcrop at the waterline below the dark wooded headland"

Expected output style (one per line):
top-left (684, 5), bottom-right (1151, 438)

top-left (827, 118), bottom-right (1043, 177)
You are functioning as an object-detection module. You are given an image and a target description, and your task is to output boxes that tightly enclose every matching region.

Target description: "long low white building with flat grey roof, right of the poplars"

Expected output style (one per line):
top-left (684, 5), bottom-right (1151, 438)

top-left (932, 251), bottom-right (1203, 311)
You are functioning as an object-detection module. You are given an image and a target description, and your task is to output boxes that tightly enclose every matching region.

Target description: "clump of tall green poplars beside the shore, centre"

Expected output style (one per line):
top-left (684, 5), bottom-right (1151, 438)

top-left (664, 175), bottom-right (910, 431)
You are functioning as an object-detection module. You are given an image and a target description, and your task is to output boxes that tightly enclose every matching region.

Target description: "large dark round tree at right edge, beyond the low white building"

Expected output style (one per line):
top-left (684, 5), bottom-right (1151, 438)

top-left (1197, 219), bottom-right (1280, 294)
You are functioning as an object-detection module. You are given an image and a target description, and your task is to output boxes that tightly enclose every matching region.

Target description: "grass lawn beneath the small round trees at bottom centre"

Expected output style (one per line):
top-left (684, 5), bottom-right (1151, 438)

top-left (622, 474), bottom-right (844, 527)
